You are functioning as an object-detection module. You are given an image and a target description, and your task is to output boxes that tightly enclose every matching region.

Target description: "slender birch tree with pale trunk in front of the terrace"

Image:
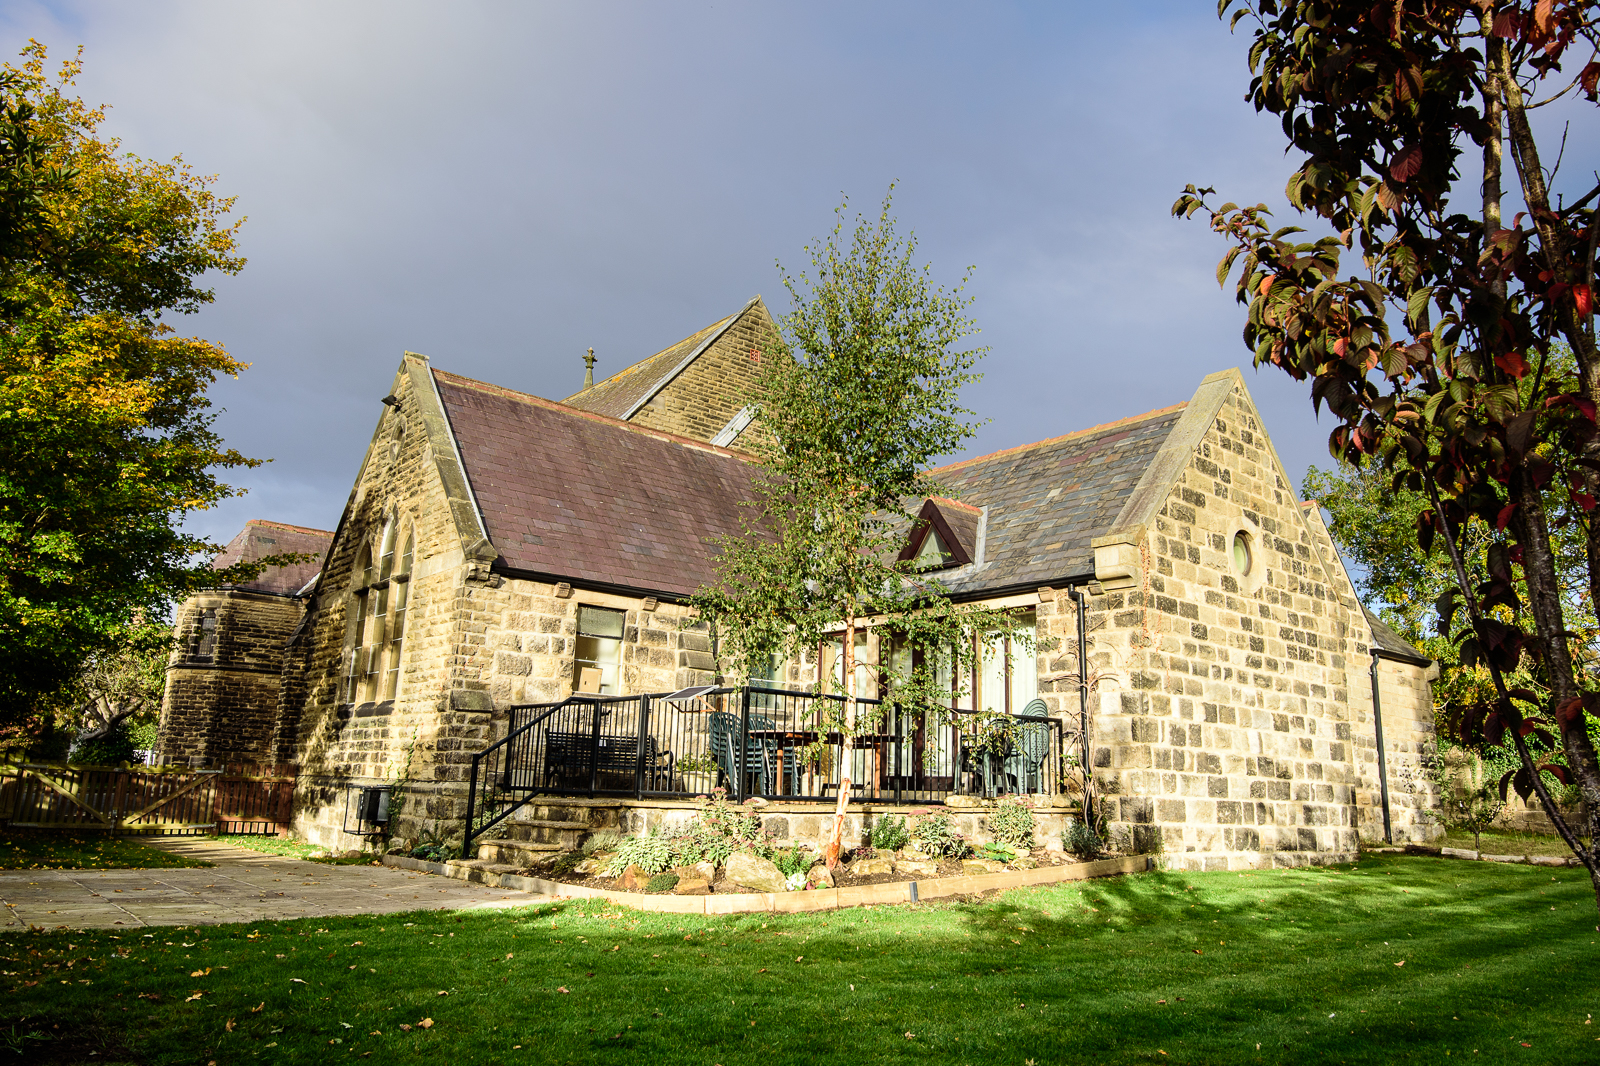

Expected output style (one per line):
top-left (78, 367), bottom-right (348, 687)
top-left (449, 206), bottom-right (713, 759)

top-left (696, 186), bottom-right (1016, 866)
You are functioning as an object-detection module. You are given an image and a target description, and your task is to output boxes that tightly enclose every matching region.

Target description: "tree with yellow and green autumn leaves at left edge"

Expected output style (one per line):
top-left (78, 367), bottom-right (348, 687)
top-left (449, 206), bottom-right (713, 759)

top-left (0, 42), bottom-right (258, 725)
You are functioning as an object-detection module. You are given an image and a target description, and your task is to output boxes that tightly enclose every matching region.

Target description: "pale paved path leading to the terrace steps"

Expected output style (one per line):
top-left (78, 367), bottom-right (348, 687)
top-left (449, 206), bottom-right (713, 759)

top-left (0, 837), bottom-right (534, 930)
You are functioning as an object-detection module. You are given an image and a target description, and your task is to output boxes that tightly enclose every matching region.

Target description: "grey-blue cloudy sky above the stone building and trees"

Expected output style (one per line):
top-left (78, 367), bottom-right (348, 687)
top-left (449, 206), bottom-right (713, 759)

top-left (0, 0), bottom-right (1600, 541)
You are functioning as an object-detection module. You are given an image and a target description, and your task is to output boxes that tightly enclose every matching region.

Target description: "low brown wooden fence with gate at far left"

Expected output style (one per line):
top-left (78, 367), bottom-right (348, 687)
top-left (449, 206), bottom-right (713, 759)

top-left (0, 762), bottom-right (294, 836)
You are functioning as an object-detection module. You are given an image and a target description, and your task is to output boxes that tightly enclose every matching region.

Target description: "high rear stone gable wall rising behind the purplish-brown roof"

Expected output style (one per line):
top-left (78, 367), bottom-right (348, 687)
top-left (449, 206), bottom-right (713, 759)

top-left (630, 301), bottom-right (773, 440)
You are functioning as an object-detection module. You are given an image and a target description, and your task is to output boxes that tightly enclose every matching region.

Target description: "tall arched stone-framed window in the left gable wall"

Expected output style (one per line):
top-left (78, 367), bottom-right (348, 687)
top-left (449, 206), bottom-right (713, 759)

top-left (344, 517), bottom-right (413, 703)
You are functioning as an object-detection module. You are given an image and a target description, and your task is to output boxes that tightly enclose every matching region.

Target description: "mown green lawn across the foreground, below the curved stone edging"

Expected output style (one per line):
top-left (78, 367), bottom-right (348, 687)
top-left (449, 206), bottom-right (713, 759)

top-left (0, 856), bottom-right (1600, 1066)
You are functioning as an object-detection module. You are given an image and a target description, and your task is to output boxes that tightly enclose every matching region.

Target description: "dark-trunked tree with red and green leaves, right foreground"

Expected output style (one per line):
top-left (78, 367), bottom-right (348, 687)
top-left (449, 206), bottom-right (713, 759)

top-left (1173, 0), bottom-right (1600, 904)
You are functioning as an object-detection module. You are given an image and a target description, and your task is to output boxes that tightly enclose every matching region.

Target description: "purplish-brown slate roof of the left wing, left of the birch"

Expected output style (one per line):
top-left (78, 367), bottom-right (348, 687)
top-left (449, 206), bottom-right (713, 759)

top-left (432, 368), bottom-right (750, 597)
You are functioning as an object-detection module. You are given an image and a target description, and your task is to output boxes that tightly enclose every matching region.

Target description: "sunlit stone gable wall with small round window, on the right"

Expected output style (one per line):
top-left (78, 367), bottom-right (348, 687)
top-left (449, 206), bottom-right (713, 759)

top-left (1090, 383), bottom-right (1432, 869)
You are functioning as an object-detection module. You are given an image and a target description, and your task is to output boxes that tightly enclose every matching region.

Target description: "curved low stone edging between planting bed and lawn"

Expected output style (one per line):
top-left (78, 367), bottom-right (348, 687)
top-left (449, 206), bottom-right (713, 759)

top-left (382, 855), bottom-right (1155, 914)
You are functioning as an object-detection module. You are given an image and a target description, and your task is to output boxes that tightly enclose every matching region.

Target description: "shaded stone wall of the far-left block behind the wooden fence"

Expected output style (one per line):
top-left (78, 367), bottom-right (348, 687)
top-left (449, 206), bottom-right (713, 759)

top-left (157, 589), bottom-right (304, 765)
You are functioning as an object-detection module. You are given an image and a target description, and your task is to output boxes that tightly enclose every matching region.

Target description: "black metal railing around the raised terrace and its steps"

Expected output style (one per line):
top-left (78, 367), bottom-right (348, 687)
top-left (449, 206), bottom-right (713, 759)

top-left (462, 685), bottom-right (1070, 855)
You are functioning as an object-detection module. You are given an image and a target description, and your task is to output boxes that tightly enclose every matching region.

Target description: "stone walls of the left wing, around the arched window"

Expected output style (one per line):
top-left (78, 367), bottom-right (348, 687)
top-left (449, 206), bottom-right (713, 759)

top-left (278, 355), bottom-right (726, 847)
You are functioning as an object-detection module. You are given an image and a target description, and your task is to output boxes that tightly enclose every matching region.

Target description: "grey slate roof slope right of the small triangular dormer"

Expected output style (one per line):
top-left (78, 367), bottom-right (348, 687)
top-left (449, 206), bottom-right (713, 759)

top-left (928, 403), bottom-right (1187, 595)
